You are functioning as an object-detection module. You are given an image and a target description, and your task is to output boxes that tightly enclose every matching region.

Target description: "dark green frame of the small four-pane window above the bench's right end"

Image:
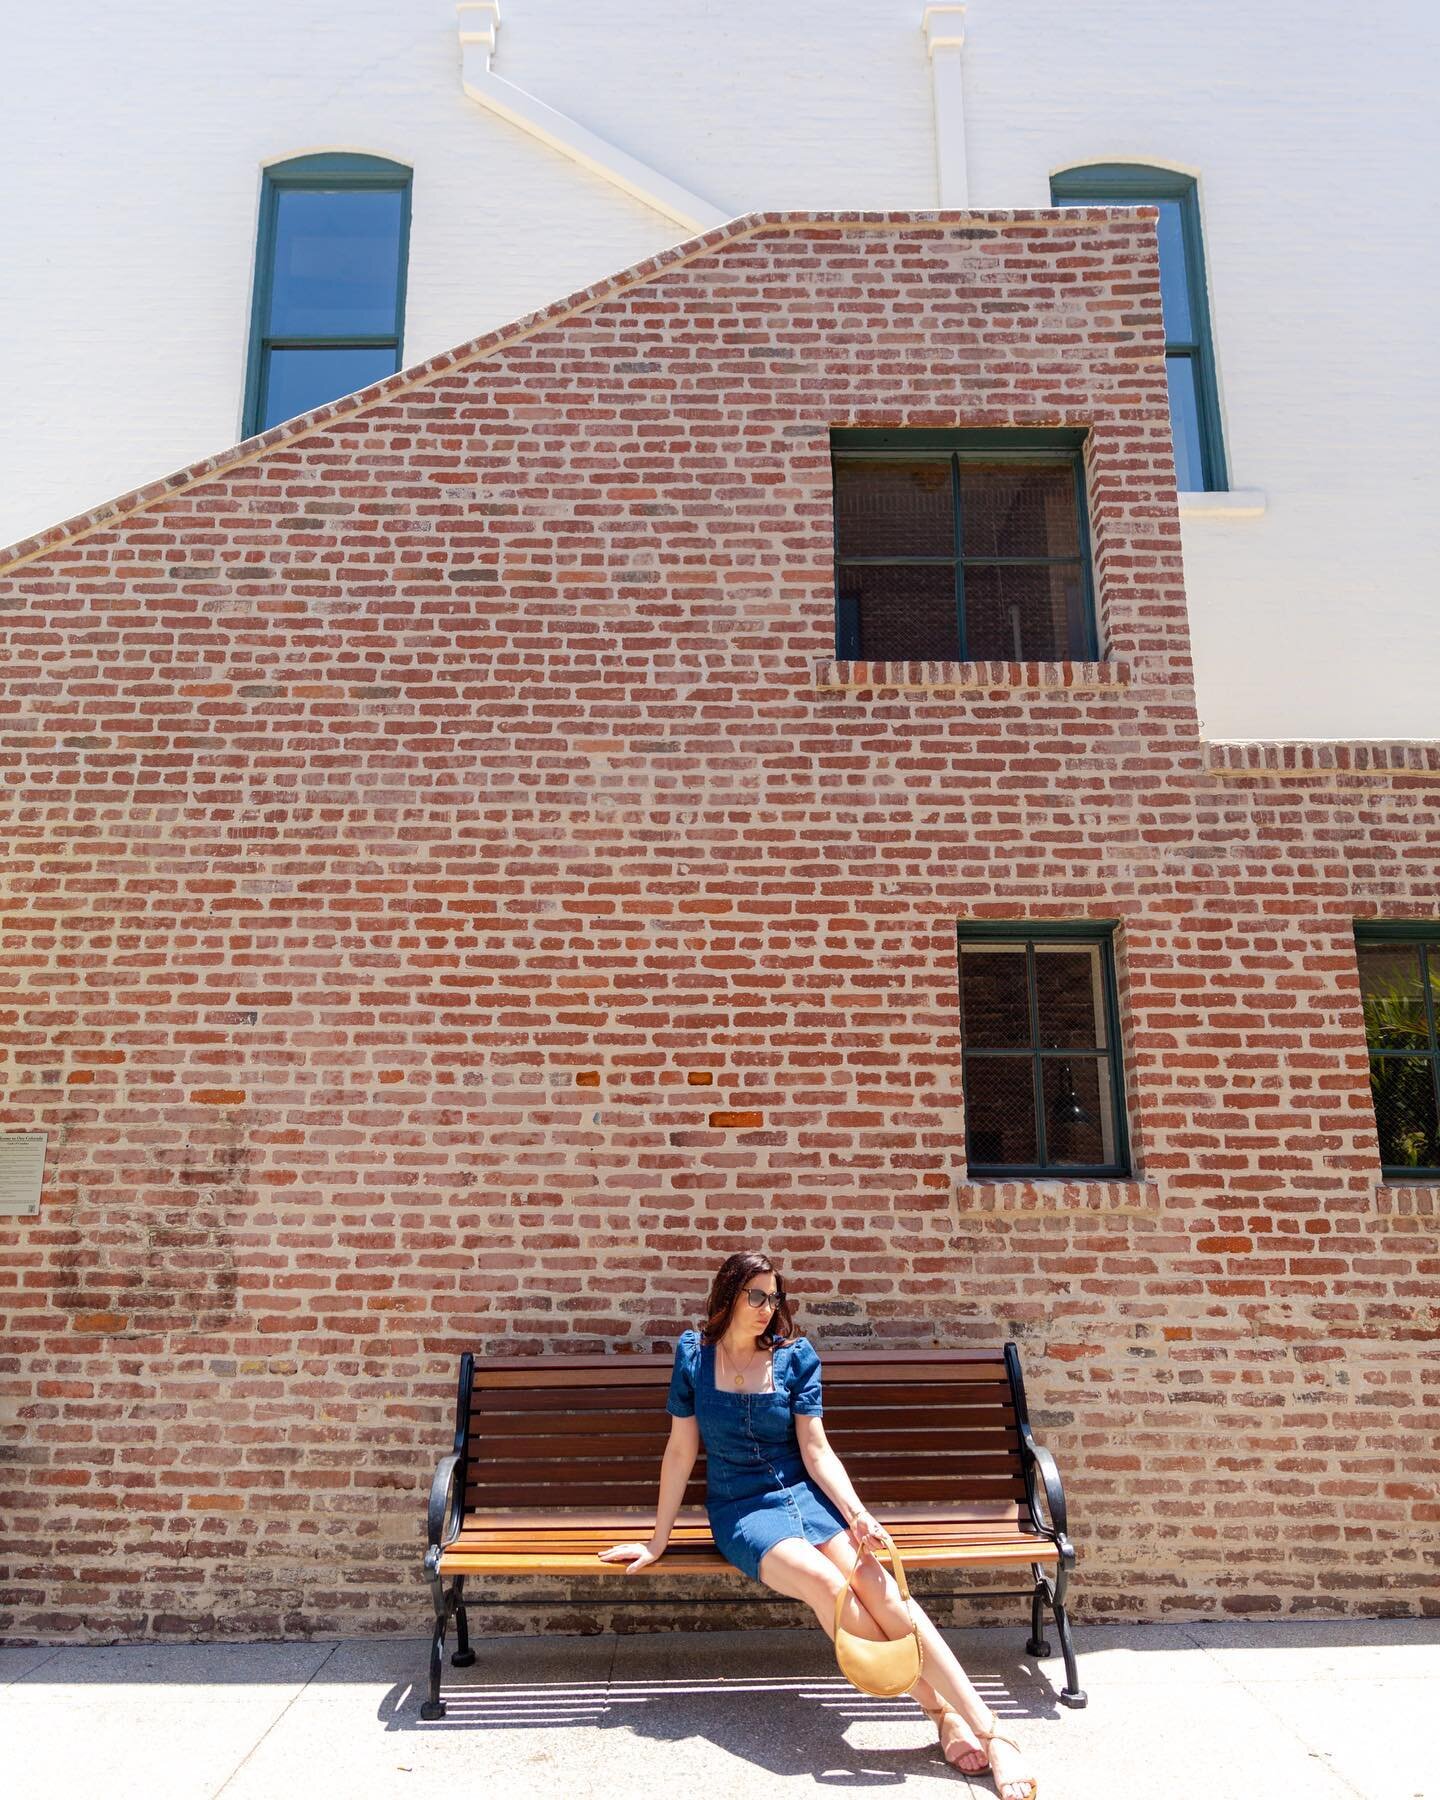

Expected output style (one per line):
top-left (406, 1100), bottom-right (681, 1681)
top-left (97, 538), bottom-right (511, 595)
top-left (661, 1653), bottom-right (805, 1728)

top-left (956, 920), bottom-right (1130, 1181)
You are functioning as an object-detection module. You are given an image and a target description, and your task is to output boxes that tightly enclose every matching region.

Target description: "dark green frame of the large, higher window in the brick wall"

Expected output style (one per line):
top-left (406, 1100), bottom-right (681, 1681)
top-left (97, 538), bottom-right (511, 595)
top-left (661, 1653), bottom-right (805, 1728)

top-left (830, 428), bottom-right (1100, 662)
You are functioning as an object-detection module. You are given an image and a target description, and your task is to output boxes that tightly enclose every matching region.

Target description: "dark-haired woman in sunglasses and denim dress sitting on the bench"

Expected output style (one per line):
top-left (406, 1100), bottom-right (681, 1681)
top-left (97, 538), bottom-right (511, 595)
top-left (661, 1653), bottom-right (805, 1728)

top-left (599, 1251), bottom-right (1035, 1800)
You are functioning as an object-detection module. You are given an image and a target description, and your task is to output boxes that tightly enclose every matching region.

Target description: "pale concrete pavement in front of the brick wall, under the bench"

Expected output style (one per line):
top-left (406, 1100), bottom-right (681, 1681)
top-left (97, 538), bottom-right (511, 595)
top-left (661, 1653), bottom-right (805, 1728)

top-left (0, 1620), bottom-right (1440, 1800)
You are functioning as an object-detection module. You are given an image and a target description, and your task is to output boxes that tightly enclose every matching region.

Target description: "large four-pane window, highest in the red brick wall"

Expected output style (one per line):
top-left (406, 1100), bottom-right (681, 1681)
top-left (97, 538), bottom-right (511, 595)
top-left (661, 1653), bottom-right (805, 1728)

top-left (832, 430), bottom-right (1096, 662)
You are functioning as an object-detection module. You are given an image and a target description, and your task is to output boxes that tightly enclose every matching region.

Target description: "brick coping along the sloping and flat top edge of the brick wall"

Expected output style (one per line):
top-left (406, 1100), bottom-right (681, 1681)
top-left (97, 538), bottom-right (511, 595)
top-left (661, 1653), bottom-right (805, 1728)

top-left (0, 207), bottom-right (1152, 574)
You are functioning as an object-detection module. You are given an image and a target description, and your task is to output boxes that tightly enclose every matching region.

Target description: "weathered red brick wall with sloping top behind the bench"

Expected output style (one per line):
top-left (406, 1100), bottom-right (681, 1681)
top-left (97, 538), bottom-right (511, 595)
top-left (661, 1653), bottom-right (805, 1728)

top-left (0, 211), bottom-right (1440, 1638)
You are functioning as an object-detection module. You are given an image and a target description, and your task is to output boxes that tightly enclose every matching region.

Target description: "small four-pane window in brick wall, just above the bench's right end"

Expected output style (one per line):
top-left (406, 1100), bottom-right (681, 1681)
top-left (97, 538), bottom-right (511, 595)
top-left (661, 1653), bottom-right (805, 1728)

top-left (959, 923), bottom-right (1129, 1175)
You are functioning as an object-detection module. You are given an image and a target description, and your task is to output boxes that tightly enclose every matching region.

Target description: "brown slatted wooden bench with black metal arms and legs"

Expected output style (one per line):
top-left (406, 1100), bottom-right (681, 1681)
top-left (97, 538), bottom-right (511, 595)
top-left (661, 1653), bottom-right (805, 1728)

top-left (421, 1343), bottom-right (1085, 1719)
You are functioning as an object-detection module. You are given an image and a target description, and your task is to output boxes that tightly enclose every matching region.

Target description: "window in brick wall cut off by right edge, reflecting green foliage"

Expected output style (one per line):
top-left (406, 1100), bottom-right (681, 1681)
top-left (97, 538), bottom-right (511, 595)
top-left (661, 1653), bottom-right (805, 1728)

top-left (1355, 920), bottom-right (1440, 1181)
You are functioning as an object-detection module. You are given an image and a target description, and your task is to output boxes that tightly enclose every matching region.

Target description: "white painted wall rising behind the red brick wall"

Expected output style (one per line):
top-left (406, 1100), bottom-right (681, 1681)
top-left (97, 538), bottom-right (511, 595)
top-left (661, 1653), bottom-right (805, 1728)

top-left (0, 0), bottom-right (1440, 738)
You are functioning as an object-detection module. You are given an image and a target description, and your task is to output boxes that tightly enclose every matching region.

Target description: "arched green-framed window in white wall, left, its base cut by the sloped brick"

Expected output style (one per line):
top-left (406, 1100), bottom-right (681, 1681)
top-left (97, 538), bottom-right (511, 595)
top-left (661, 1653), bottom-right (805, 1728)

top-left (245, 155), bottom-right (410, 437)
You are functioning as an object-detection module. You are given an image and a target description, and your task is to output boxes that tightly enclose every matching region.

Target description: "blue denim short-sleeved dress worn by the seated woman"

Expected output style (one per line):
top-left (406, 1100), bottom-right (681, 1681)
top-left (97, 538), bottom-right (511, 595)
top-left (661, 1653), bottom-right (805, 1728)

top-left (666, 1332), bottom-right (846, 1580)
